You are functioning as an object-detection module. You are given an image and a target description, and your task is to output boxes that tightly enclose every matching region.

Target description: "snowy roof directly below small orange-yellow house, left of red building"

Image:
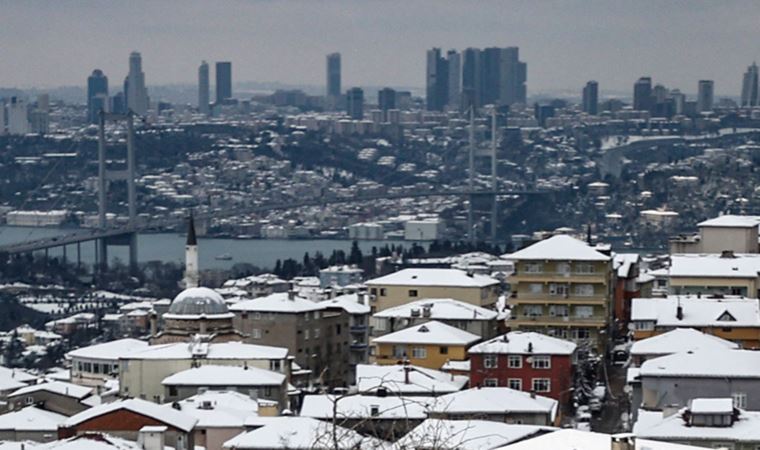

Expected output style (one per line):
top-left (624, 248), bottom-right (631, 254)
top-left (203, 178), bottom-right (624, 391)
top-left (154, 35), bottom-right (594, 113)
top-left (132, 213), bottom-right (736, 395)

top-left (356, 364), bottom-right (469, 395)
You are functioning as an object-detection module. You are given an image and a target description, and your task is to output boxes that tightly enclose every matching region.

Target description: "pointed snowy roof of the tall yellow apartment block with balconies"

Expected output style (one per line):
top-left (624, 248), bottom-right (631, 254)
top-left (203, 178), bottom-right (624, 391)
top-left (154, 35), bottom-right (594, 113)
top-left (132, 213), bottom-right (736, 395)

top-left (503, 234), bottom-right (610, 261)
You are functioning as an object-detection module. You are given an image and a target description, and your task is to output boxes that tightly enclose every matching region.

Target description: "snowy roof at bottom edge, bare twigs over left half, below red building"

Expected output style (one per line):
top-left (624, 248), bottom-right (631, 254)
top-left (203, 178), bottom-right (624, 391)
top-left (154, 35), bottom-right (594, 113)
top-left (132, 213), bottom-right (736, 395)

top-left (394, 419), bottom-right (552, 450)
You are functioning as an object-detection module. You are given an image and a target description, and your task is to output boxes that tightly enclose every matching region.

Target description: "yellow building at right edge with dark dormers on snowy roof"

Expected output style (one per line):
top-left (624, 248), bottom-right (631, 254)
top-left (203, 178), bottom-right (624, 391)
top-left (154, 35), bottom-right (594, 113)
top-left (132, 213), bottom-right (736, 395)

top-left (631, 295), bottom-right (760, 349)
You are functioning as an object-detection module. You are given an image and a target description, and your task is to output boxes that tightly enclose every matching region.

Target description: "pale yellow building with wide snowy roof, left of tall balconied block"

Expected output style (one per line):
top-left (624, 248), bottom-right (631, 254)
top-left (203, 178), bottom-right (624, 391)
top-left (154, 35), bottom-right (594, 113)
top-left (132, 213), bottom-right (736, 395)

top-left (366, 269), bottom-right (500, 314)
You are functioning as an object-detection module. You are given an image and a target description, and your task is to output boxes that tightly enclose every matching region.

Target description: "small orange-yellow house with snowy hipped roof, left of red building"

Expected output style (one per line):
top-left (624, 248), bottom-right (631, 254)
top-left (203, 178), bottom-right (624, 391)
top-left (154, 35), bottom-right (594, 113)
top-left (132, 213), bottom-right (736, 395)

top-left (372, 320), bottom-right (480, 369)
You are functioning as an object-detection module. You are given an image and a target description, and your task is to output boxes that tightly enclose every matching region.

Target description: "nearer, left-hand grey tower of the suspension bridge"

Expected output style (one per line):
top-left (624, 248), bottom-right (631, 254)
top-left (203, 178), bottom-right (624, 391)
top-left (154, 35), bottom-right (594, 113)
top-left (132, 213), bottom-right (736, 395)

top-left (95, 111), bottom-right (137, 273)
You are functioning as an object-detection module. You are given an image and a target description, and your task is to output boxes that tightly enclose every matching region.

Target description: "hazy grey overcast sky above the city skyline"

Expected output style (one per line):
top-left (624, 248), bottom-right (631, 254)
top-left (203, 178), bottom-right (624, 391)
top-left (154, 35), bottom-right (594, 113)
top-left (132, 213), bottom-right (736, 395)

top-left (0, 0), bottom-right (760, 95)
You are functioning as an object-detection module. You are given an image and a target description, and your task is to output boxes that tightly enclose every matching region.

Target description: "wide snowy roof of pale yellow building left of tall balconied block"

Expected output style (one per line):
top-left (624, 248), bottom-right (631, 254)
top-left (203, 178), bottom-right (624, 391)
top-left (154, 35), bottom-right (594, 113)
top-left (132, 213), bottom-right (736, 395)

top-left (365, 269), bottom-right (499, 288)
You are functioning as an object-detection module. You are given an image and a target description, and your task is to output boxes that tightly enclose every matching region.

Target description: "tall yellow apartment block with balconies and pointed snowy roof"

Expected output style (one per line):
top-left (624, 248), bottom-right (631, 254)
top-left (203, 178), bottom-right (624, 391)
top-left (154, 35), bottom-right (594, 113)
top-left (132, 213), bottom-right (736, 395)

top-left (505, 235), bottom-right (612, 350)
